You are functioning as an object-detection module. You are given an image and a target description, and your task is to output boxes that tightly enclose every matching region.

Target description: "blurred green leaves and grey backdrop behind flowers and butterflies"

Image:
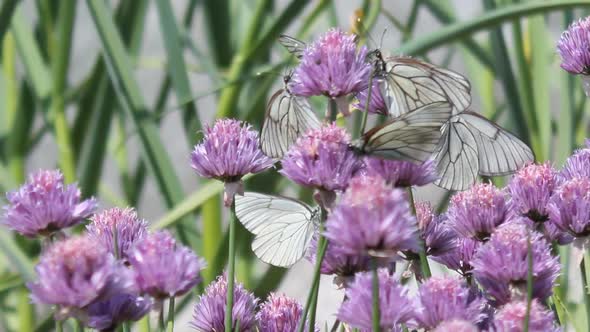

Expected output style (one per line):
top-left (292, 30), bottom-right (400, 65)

top-left (0, 0), bottom-right (590, 331)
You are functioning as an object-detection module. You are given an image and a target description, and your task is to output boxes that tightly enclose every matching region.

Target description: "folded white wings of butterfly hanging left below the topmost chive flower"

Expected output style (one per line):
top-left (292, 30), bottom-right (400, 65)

top-left (260, 90), bottom-right (321, 158)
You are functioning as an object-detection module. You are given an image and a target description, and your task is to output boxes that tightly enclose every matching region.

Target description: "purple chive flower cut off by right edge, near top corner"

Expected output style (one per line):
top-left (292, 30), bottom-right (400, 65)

top-left (557, 17), bottom-right (590, 75)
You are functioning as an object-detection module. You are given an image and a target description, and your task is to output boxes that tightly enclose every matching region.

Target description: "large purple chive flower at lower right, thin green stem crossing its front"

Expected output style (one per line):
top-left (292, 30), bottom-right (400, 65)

top-left (471, 223), bottom-right (560, 304)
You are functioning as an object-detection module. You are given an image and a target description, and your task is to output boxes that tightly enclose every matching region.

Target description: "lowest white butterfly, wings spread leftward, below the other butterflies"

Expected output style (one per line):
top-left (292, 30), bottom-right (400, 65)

top-left (235, 192), bottom-right (321, 267)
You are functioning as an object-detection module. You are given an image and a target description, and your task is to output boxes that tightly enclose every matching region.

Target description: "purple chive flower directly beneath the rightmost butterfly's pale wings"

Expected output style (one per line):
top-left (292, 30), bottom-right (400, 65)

top-left (447, 183), bottom-right (508, 241)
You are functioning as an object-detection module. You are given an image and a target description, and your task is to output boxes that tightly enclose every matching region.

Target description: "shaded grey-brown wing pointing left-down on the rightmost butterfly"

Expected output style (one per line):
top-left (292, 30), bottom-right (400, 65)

top-left (362, 102), bottom-right (451, 162)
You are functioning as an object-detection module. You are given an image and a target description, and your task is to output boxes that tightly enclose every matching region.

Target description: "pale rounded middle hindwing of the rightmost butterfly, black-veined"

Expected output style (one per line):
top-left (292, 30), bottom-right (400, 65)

top-left (434, 116), bottom-right (479, 190)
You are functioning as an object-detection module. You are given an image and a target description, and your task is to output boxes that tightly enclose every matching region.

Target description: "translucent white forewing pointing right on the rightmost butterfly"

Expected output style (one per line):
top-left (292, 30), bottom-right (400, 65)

top-left (459, 111), bottom-right (535, 176)
